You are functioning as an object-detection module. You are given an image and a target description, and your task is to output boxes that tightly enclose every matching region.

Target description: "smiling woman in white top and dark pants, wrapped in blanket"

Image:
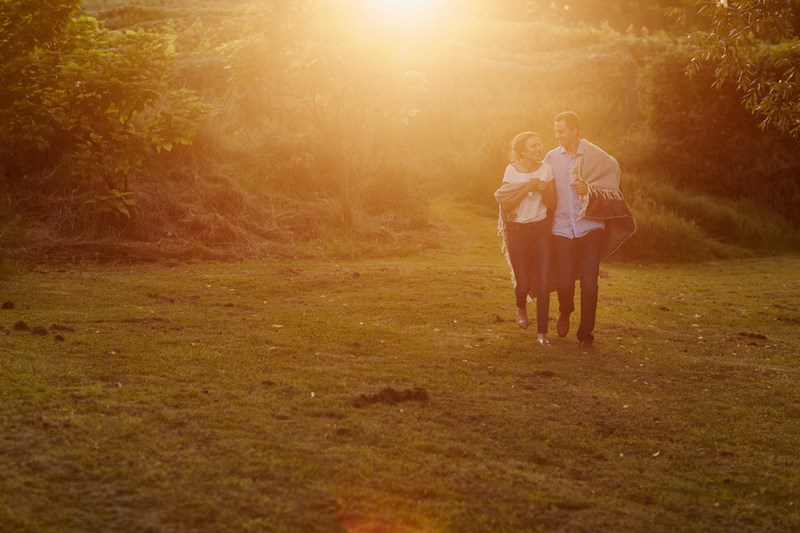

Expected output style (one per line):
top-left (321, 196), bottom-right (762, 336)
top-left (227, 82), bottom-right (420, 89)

top-left (494, 131), bottom-right (556, 346)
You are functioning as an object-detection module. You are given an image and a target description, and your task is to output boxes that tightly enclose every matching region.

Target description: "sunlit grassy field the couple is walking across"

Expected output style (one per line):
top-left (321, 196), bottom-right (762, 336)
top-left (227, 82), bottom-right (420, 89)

top-left (0, 206), bottom-right (800, 532)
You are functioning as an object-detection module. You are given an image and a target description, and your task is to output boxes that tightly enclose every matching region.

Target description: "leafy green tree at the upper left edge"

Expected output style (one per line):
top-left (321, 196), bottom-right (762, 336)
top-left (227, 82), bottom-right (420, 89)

top-left (0, 1), bottom-right (206, 222)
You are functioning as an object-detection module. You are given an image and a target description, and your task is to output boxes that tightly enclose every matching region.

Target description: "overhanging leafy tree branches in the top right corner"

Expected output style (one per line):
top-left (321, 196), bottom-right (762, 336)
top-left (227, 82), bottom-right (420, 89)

top-left (672, 0), bottom-right (800, 138)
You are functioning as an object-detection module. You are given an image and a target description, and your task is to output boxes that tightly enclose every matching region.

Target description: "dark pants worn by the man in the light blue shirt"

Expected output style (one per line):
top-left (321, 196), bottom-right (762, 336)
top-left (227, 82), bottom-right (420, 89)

top-left (553, 229), bottom-right (603, 343)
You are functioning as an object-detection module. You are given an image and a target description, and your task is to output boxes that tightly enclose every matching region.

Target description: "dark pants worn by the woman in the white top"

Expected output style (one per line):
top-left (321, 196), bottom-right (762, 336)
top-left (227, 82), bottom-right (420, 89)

top-left (506, 219), bottom-right (551, 333)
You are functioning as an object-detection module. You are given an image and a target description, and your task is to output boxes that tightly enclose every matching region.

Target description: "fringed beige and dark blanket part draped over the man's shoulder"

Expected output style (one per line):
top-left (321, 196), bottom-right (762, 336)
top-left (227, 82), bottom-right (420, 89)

top-left (570, 140), bottom-right (636, 257)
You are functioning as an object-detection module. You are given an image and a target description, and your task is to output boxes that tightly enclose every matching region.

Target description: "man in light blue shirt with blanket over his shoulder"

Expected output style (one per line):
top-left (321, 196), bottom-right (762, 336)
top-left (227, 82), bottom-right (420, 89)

top-left (544, 111), bottom-right (636, 350)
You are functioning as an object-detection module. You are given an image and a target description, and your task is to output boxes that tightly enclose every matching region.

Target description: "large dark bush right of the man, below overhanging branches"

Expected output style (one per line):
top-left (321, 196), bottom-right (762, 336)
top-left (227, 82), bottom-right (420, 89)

top-left (626, 49), bottom-right (800, 222)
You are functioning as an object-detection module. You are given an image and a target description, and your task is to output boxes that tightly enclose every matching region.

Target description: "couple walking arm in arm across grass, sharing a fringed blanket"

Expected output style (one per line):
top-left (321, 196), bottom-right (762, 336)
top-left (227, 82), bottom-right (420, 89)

top-left (495, 111), bottom-right (636, 350)
